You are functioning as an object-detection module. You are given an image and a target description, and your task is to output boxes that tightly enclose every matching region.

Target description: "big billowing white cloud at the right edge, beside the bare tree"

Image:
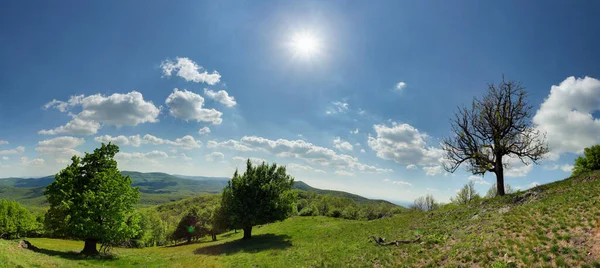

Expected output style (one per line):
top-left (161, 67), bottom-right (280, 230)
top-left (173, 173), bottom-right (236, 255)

top-left (533, 76), bottom-right (600, 160)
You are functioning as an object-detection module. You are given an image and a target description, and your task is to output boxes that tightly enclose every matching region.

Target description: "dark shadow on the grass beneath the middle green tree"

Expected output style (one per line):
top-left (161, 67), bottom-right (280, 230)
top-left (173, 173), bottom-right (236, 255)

top-left (194, 234), bottom-right (292, 255)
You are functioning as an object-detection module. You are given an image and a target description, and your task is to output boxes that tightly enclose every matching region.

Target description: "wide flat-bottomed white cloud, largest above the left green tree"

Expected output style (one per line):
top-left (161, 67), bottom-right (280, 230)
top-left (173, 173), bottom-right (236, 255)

top-left (38, 91), bottom-right (160, 135)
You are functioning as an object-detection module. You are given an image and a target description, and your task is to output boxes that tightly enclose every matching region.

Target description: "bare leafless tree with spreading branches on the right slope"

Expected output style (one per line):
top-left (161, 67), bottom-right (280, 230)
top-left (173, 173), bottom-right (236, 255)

top-left (442, 76), bottom-right (548, 195)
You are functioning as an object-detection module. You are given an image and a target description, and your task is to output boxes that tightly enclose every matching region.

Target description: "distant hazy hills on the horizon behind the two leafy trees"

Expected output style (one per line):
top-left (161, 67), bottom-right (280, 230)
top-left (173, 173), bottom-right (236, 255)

top-left (0, 171), bottom-right (400, 207)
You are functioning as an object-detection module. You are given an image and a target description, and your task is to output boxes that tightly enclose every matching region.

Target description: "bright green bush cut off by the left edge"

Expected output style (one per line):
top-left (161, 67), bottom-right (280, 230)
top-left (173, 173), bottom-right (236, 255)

top-left (0, 199), bottom-right (41, 239)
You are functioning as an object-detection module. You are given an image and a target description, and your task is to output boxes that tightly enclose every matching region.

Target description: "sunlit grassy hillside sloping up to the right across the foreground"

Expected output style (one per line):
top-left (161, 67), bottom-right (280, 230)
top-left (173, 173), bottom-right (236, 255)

top-left (5, 172), bottom-right (600, 267)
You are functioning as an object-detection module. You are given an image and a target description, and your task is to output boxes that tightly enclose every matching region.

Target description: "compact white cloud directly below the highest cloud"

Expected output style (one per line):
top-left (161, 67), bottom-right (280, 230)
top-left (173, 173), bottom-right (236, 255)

top-left (165, 88), bottom-right (223, 125)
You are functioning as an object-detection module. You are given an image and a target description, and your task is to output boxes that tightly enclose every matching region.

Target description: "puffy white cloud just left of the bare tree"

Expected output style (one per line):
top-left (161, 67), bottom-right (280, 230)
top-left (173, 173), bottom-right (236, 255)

top-left (368, 122), bottom-right (443, 166)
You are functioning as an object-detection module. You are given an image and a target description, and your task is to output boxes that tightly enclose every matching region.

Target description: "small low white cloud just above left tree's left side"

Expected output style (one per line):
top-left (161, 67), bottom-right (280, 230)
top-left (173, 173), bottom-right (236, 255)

top-left (35, 136), bottom-right (85, 163)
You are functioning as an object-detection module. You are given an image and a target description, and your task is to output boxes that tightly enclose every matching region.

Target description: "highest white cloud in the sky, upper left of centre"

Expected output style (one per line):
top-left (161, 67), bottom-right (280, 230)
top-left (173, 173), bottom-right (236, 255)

top-left (160, 57), bottom-right (221, 85)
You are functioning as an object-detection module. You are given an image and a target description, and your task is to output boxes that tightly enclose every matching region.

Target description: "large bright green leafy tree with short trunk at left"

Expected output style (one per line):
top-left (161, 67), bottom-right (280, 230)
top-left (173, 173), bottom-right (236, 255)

top-left (44, 143), bottom-right (139, 255)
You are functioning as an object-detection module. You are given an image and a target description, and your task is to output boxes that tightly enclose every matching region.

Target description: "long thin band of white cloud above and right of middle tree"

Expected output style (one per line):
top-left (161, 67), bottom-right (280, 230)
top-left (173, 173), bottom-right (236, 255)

top-left (213, 136), bottom-right (392, 173)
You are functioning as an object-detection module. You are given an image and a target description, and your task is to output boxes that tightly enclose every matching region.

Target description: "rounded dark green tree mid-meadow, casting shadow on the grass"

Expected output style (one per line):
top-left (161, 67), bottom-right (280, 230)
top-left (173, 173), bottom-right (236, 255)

top-left (222, 159), bottom-right (296, 239)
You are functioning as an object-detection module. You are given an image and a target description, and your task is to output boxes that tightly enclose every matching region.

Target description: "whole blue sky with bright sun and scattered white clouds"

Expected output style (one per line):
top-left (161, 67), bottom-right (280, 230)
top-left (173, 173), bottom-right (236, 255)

top-left (0, 1), bottom-right (600, 202)
